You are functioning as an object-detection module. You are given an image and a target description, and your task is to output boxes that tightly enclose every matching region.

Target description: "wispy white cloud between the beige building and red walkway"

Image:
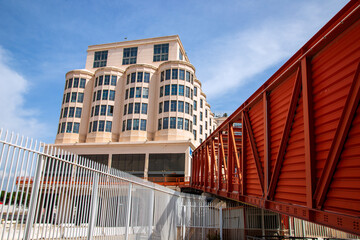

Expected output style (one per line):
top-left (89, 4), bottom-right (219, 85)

top-left (196, 3), bottom-right (341, 98)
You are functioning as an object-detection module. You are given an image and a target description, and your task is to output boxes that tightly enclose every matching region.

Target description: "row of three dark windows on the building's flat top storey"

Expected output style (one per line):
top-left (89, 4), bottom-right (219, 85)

top-left (93, 43), bottom-right (169, 68)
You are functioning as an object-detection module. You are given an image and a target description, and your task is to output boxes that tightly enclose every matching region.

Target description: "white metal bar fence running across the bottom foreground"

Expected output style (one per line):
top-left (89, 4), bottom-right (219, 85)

top-left (0, 130), bottom-right (355, 240)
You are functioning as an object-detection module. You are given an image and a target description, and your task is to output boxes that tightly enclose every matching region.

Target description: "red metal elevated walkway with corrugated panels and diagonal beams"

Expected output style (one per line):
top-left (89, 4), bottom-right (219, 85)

top-left (191, 1), bottom-right (360, 235)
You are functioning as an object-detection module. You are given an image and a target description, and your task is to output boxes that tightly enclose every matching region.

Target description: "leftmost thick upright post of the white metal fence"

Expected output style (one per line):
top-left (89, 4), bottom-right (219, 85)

top-left (24, 155), bottom-right (44, 240)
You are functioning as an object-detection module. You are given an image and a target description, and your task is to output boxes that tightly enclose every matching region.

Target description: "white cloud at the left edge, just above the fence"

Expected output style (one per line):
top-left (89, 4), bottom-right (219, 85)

top-left (0, 46), bottom-right (48, 141)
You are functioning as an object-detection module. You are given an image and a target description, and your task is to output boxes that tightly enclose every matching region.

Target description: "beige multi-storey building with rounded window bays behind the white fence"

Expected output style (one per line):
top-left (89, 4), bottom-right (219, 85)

top-left (54, 36), bottom-right (216, 181)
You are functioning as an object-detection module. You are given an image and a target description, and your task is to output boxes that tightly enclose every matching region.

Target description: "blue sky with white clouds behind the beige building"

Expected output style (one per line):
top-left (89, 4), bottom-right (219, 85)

top-left (0, 0), bottom-right (348, 143)
